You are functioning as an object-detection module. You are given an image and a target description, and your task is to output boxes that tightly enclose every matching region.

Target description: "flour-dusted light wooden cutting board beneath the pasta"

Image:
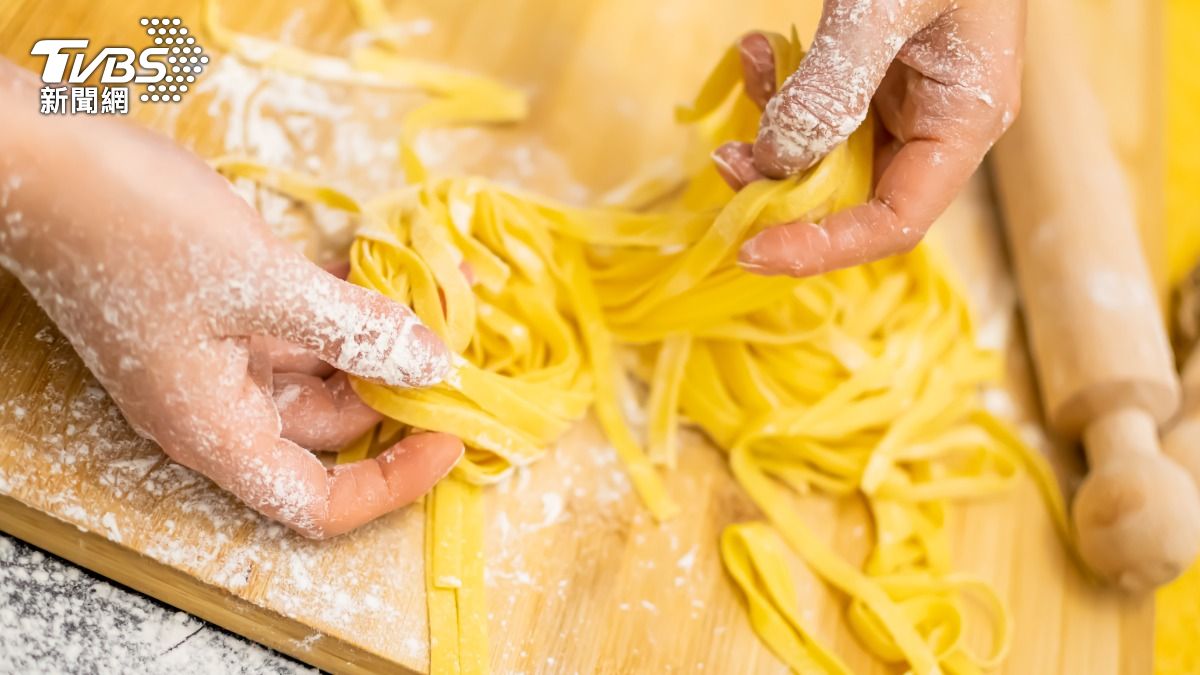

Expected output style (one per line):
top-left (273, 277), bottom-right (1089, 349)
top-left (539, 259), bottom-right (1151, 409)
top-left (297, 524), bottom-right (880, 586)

top-left (0, 0), bottom-right (1153, 674)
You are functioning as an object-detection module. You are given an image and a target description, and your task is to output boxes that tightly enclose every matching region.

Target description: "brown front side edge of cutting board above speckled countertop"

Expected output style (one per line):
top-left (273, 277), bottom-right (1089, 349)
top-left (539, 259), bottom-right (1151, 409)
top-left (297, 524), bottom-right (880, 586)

top-left (0, 495), bottom-right (419, 675)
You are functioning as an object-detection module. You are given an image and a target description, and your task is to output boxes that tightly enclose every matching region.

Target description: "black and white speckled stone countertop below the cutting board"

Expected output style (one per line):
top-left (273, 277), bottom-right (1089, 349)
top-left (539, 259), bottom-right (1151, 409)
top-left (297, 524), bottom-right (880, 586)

top-left (0, 534), bottom-right (316, 675)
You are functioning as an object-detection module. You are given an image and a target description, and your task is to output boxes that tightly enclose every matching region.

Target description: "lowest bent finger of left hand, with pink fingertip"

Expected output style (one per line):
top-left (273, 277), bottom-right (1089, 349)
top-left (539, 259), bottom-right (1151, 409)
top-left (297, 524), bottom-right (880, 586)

top-left (150, 340), bottom-right (463, 538)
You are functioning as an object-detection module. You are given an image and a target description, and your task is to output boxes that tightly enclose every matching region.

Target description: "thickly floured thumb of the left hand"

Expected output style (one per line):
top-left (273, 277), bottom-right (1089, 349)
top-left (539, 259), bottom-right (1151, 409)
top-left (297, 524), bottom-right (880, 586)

top-left (239, 256), bottom-right (450, 387)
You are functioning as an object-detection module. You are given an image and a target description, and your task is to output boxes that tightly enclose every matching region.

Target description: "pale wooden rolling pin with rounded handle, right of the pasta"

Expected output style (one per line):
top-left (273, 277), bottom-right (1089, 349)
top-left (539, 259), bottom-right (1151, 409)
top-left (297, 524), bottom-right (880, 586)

top-left (992, 0), bottom-right (1200, 590)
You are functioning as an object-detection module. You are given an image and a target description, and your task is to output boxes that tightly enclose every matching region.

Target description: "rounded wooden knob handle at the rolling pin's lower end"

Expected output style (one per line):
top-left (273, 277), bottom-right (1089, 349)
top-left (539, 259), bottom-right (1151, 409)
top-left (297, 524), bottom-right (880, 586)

top-left (1072, 407), bottom-right (1200, 591)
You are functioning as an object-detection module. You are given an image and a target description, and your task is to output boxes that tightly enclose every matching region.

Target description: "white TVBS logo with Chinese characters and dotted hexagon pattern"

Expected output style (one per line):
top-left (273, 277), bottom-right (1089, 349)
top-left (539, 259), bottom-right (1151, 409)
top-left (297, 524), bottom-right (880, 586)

top-left (30, 17), bottom-right (209, 114)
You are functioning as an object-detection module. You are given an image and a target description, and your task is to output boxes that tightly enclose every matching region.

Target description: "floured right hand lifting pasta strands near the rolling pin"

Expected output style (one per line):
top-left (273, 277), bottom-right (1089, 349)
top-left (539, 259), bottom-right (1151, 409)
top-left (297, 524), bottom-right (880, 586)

top-left (714, 0), bottom-right (1025, 276)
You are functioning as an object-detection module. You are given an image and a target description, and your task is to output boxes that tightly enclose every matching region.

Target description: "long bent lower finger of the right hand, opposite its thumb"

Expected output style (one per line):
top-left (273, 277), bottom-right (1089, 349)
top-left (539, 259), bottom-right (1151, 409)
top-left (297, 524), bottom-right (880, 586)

top-left (739, 4), bottom-right (1024, 276)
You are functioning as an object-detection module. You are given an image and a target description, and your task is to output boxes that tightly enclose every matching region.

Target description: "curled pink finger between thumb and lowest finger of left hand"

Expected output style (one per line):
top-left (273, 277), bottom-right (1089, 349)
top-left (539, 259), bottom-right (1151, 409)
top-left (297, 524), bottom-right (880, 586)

top-left (272, 372), bottom-right (383, 452)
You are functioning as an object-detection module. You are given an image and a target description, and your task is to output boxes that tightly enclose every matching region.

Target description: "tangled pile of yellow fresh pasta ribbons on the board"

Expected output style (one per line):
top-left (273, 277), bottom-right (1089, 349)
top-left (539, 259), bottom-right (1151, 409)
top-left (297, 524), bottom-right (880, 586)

top-left (209, 6), bottom-right (1068, 674)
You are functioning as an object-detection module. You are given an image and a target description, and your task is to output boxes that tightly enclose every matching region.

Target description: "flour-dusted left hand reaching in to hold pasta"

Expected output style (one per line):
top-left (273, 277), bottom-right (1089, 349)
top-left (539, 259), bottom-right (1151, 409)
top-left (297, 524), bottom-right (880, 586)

top-left (0, 59), bottom-right (463, 537)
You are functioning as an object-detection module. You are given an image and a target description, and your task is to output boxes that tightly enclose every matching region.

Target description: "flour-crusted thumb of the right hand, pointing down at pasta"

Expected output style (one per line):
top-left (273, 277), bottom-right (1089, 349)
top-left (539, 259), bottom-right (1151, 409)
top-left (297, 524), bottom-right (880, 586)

top-left (754, 0), bottom-right (946, 178)
